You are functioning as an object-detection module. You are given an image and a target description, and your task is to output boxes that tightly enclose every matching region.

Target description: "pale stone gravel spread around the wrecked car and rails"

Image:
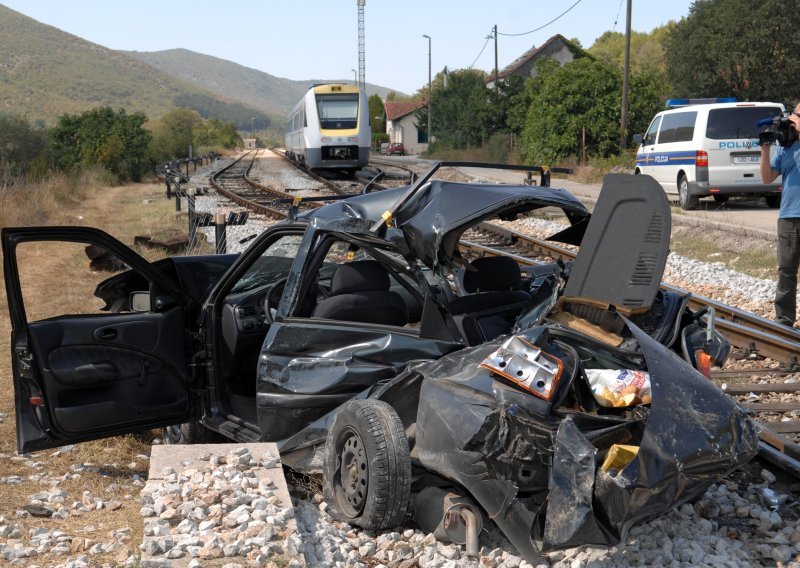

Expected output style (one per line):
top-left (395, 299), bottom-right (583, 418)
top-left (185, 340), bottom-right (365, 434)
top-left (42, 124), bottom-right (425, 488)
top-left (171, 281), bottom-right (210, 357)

top-left (0, 163), bottom-right (800, 568)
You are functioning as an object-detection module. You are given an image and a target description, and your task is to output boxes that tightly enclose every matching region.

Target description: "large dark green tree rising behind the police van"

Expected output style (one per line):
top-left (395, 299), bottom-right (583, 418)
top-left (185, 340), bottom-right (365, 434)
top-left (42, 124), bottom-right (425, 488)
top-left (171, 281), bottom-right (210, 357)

top-left (666, 0), bottom-right (800, 101)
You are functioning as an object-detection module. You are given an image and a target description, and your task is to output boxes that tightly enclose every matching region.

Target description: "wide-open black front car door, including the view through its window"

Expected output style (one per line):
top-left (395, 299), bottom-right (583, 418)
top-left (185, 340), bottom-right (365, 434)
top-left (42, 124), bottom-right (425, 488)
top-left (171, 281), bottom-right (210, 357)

top-left (2, 227), bottom-right (194, 452)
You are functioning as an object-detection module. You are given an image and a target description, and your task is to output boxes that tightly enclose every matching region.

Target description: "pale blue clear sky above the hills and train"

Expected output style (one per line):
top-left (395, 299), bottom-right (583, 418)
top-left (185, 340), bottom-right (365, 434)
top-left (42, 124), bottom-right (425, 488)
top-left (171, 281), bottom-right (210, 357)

top-left (0, 0), bottom-right (692, 94)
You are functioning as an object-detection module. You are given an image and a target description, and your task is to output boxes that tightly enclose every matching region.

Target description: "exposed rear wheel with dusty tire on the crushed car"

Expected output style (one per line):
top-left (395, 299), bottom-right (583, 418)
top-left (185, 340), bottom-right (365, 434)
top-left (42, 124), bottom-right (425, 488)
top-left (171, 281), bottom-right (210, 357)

top-left (323, 399), bottom-right (411, 530)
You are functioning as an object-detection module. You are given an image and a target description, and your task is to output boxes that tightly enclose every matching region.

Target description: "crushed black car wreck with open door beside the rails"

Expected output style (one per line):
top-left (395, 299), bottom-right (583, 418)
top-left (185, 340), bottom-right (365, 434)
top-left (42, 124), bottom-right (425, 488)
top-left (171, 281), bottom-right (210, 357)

top-left (2, 165), bottom-right (757, 559)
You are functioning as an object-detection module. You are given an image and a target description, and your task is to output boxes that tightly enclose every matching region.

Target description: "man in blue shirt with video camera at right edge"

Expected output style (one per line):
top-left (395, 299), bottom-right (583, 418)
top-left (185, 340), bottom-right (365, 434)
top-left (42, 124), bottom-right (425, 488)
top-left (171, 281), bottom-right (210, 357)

top-left (761, 104), bottom-right (800, 326)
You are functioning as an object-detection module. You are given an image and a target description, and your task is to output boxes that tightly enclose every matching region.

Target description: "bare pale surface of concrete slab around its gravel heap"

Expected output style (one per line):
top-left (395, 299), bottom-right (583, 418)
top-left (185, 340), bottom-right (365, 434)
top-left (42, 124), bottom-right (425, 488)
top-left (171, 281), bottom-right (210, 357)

top-left (140, 443), bottom-right (305, 568)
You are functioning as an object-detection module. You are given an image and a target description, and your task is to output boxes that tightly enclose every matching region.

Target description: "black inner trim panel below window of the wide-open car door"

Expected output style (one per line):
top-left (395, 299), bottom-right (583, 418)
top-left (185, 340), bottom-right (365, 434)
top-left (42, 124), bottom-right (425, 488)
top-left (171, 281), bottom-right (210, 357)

top-left (29, 310), bottom-right (188, 433)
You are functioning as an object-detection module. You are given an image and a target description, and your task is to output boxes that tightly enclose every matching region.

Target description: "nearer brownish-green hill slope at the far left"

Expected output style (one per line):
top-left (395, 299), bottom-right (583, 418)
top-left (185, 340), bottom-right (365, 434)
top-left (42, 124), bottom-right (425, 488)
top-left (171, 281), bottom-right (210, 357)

top-left (0, 5), bottom-right (268, 130)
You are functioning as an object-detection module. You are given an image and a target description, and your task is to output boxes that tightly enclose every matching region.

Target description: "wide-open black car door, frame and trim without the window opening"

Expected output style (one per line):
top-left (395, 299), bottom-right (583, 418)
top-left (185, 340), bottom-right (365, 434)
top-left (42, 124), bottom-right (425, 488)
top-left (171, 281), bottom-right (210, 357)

top-left (2, 227), bottom-right (198, 452)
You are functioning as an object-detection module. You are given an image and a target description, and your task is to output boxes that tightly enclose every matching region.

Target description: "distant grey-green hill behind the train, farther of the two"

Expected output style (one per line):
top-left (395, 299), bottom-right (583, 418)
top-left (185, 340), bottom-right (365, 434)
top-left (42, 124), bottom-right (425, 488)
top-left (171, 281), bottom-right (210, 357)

top-left (124, 49), bottom-right (402, 117)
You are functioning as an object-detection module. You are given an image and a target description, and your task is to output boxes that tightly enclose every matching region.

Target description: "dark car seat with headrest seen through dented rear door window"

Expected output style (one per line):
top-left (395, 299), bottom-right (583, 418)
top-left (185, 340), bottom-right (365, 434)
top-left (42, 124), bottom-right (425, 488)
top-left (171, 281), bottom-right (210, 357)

top-left (312, 260), bottom-right (408, 326)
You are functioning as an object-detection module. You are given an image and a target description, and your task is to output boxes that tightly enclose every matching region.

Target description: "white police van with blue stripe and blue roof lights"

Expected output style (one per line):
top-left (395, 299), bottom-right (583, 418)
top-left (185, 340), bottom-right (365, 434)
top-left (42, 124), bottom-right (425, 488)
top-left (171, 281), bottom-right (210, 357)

top-left (634, 99), bottom-right (784, 210)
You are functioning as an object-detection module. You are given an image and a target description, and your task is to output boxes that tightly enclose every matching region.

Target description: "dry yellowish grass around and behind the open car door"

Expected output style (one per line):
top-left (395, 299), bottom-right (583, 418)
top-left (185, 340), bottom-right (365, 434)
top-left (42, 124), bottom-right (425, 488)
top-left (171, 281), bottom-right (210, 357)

top-left (0, 174), bottom-right (186, 565)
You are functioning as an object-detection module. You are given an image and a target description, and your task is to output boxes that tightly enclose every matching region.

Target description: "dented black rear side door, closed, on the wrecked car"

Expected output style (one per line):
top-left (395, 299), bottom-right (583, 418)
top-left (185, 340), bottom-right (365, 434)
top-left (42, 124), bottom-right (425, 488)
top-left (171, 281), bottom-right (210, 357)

top-left (256, 230), bottom-right (463, 441)
